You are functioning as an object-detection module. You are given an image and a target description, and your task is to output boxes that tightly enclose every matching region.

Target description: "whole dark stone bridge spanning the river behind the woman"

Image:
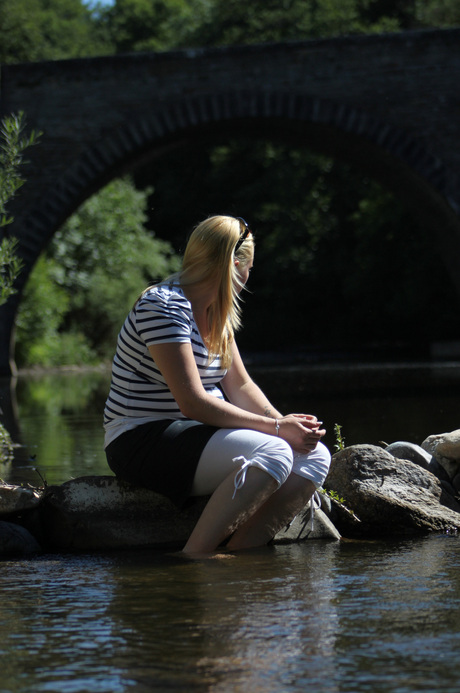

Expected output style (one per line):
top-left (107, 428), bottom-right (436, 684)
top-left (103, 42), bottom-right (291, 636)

top-left (0, 29), bottom-right (460, 374)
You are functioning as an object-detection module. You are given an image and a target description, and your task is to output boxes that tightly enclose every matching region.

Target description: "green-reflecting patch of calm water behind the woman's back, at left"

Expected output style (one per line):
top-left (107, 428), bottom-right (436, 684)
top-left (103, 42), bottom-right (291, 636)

top-left (0, 369), bottom-right (110, 485)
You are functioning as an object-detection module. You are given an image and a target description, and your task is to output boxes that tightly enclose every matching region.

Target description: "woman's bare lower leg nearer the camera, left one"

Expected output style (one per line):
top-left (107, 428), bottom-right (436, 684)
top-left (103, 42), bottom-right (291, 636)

top-left (183, 467), bottom-right (276, 554)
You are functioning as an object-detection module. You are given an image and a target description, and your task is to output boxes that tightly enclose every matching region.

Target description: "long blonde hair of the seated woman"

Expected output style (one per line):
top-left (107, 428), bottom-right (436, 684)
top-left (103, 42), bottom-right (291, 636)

top-left (179, 216), bottom-right (254, 368)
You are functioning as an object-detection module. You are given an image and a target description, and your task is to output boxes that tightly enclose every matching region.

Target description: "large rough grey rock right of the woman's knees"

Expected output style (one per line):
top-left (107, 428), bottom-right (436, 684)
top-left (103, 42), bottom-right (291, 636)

top-left (325, 445), bottom-right (460, 538)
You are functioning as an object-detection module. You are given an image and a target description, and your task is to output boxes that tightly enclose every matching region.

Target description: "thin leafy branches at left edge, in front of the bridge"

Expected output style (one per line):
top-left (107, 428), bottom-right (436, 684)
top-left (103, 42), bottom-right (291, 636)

top-left (0, 113), bottom-right (40, 305)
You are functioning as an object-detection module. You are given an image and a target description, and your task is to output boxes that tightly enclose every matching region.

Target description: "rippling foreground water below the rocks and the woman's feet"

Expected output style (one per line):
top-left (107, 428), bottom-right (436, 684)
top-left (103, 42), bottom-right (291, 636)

top-left (0, 536), bottom-right (460, 693)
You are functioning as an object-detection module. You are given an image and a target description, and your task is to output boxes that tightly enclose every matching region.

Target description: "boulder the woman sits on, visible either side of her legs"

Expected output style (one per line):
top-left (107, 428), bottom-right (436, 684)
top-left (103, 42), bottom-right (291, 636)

top-left (41, 476), bottom-right (340, 550)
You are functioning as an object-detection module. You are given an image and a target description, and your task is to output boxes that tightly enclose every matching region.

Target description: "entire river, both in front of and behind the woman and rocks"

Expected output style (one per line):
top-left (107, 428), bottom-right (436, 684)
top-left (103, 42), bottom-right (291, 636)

top-left (0, 364), bottom-right (460, 693)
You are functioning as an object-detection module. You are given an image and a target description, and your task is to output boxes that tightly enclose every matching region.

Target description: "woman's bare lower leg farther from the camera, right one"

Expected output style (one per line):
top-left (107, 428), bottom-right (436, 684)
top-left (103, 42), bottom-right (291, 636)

top-left (227, 474), bottom-right (316, 550)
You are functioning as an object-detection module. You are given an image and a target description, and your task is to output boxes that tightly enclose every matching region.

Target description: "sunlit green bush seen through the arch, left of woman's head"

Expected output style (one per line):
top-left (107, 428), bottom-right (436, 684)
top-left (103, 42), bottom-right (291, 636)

top-left (16, 179), bottom-right (179, 366)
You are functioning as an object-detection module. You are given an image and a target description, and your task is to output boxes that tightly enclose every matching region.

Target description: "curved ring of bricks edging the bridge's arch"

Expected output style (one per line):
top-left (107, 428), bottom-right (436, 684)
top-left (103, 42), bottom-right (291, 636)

top-left (0, 90), bottom-right (460, 372)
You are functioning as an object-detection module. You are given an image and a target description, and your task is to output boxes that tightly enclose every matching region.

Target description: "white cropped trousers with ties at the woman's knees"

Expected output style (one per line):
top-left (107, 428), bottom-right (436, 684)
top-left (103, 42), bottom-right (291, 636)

top-left (191, 428), bottom-right (331, 496)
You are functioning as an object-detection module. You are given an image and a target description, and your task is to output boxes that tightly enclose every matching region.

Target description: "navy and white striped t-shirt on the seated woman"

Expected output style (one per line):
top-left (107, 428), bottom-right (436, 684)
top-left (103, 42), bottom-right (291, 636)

top-left (104, 284), bottom-right (226, 445)
